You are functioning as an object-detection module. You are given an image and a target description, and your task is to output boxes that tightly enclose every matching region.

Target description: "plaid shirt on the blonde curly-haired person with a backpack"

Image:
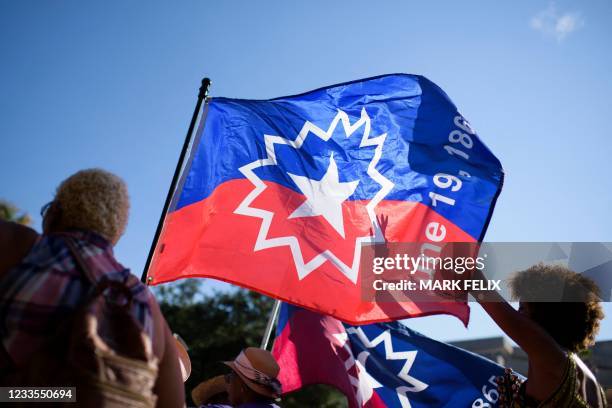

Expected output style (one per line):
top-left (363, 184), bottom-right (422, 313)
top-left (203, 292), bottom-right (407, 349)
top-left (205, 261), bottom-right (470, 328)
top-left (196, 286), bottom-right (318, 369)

top-left (0, 231), bottom-right (153, 367)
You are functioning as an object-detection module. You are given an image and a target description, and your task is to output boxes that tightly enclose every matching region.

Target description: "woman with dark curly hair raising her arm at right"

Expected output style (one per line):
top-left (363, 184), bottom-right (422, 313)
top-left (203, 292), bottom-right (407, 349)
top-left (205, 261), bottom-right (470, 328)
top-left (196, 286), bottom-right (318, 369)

top-left (473, 264), bottom-right (607, 408)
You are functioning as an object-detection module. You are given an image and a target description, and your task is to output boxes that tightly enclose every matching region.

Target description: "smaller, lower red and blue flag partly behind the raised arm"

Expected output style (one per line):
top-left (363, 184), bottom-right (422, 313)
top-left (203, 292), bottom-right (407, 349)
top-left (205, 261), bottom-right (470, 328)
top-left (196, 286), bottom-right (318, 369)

top-left (272, 304), bottom-right (504, 408)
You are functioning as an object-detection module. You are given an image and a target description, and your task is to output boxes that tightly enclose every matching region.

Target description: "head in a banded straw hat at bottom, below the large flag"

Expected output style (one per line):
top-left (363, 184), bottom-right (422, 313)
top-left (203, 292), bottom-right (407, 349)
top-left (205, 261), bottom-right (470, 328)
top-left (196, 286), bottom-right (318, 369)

top-left (225, 347), bottom-right (281, 406)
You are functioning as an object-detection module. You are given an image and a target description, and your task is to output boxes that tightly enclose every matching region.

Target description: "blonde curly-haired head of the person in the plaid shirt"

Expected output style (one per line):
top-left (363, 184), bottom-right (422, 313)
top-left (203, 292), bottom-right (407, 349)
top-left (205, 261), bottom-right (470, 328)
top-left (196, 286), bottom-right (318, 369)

top-left (43, 169), bottom-right (130, 245)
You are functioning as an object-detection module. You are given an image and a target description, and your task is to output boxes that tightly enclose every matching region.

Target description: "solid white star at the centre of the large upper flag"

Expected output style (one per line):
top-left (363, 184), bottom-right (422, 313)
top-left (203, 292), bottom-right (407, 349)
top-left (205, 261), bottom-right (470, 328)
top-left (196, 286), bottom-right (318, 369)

top-left (287, 154), bottom-right (359, 238)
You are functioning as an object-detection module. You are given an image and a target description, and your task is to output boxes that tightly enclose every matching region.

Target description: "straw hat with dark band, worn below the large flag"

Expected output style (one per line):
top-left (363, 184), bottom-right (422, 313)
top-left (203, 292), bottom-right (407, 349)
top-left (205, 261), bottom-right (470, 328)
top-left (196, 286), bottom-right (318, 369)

top-left (223, 347), bottom-right (282, 398)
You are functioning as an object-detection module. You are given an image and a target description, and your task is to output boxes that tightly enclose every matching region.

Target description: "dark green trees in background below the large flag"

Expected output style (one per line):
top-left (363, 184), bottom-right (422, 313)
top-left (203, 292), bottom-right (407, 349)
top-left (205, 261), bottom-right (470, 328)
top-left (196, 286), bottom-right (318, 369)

top-left (154, 279), bottom-right (347, 408)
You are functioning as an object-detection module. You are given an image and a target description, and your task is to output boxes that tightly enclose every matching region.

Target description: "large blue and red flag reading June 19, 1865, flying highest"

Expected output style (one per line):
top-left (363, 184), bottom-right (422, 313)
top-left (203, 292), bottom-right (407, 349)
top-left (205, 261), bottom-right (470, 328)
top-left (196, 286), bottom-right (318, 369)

top-left (148, 74), bottom-right (503, 323)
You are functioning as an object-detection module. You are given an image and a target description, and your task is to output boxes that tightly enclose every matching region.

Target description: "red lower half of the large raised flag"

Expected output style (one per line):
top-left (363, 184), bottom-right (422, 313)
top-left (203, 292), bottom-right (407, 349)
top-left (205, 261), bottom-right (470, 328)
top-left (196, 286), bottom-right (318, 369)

top-left (148, 180), bottom-right (474, 324)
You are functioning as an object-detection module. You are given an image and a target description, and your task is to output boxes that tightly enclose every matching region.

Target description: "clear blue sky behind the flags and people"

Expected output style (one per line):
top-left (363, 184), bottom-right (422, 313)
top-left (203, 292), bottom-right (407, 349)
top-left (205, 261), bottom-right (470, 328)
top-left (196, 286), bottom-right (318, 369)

top-left (0, 0), bottom-right (612, 340)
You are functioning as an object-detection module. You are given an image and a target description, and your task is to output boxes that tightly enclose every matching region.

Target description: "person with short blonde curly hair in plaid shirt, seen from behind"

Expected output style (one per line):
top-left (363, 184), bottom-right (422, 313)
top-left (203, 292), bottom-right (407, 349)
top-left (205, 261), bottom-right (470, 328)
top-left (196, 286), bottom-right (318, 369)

top-left (0, 169), bottom-right (185, 407)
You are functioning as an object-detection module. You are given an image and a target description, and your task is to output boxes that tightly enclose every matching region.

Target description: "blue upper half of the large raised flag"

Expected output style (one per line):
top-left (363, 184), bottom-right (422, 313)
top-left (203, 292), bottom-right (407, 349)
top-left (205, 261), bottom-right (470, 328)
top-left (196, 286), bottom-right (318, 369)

top-left (175, 74), bottom-right (503, 239)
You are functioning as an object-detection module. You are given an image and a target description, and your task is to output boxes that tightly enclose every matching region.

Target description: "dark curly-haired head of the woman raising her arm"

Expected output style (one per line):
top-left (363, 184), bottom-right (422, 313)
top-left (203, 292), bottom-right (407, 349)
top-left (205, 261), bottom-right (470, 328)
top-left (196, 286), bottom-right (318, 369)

top-left (510, 263), bottom-right (604, 352)
